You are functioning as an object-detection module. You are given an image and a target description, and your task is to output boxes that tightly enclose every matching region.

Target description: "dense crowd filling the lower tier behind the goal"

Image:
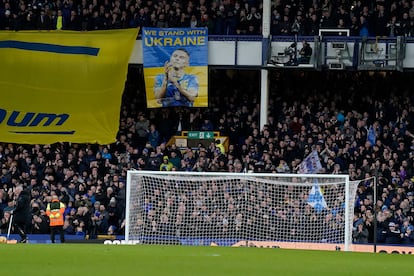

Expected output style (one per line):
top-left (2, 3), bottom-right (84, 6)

top-left (0, 68), bottom-right (414, 245)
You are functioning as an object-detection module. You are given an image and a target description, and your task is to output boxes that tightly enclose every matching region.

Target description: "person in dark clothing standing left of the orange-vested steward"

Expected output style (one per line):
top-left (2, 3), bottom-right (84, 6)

top-left (12, 185), bottom-right (30, 243)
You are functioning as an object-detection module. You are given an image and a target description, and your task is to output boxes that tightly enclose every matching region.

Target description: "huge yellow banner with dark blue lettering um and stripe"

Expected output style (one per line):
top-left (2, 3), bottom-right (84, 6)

top-left (0, 29), bottom-right (138, 144)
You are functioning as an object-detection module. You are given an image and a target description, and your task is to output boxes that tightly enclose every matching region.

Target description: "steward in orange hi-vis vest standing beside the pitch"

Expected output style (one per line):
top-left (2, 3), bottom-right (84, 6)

top-left (46, 195), bottom-right (66, 243)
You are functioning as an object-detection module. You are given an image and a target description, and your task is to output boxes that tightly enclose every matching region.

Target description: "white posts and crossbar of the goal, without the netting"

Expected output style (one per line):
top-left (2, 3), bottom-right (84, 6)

top-left (125, 170), bottom-right (354, 251)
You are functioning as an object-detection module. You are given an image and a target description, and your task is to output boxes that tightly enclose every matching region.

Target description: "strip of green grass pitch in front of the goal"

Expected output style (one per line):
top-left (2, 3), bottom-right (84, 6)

top-left (0, 244), bottom-right (414, 276)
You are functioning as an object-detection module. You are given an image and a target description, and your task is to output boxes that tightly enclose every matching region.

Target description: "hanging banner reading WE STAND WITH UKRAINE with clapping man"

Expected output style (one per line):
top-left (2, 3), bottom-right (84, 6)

top-left (142, 28), bottom-right (208, 108)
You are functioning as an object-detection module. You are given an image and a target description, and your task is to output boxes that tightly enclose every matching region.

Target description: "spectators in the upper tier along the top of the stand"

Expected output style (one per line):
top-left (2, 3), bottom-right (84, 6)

top-left (0, 0), bottom-right (414, 37)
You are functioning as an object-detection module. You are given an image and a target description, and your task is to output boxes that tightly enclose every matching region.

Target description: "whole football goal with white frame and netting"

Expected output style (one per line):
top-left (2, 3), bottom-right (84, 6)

top-left (125, 171), bottom-right (359, 251)
